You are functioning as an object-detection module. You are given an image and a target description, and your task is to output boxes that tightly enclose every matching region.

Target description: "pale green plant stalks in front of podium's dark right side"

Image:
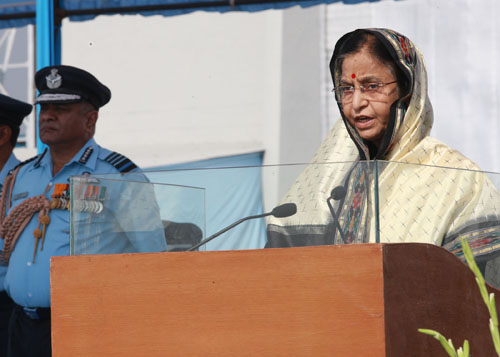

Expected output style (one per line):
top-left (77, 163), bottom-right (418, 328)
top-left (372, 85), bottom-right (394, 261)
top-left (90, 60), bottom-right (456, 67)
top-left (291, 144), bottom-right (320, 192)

top-left (418, 238), bottom-right (500, 357)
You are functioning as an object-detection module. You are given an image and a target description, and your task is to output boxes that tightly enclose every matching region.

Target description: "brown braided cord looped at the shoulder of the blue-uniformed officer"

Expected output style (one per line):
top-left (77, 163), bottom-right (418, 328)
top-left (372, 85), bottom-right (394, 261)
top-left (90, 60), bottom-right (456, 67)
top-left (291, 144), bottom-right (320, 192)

top-left (0, 167), bottom-right (50, 263)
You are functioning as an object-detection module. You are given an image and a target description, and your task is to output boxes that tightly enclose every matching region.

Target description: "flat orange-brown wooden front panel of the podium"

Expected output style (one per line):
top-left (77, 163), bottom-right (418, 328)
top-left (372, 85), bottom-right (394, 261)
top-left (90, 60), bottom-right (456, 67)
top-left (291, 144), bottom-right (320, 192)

top-left (51, 245), bottom-right (385, 357)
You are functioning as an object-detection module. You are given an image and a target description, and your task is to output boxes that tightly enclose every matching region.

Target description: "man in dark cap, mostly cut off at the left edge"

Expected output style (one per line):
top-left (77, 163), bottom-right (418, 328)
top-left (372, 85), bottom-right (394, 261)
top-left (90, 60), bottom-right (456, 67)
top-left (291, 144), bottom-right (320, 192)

top-left (0, 94), bottom-right (33, 356)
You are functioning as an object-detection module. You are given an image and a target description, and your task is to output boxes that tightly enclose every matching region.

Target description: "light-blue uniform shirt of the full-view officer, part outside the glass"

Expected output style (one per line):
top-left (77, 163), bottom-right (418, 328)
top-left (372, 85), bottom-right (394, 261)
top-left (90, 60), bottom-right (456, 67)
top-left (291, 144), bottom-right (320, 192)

top-left (1, 139), bottom-right (166, 307)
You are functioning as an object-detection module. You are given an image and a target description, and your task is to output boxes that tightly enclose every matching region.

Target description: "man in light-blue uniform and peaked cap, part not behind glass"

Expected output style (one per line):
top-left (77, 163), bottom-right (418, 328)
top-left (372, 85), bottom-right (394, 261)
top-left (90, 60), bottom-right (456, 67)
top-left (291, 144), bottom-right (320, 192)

top-left (0, 66), bottom-right (166, 357)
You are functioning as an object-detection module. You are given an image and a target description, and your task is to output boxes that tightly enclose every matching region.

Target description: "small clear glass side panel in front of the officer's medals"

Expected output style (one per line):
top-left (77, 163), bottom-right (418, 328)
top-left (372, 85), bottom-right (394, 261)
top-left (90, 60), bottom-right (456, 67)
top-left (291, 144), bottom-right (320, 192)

top-left (69, 174), bottom-right (205, 255)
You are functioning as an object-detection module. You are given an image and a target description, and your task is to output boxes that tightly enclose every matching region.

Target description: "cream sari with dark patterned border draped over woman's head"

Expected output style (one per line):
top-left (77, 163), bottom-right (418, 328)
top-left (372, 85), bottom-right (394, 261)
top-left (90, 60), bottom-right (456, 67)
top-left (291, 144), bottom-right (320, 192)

top-left (267, 29), bottom-right (500, 285)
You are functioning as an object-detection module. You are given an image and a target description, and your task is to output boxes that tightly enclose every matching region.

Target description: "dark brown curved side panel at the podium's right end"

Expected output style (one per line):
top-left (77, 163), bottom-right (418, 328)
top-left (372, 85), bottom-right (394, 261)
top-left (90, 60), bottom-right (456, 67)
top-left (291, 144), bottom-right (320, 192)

top-left (384, 243), bottom-right (500, 357)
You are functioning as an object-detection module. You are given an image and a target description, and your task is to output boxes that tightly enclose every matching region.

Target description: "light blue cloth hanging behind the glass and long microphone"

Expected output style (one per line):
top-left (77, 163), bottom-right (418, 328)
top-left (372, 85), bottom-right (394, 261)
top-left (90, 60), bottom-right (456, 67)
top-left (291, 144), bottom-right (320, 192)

top-left (147, 152), bottom-right (266, 250)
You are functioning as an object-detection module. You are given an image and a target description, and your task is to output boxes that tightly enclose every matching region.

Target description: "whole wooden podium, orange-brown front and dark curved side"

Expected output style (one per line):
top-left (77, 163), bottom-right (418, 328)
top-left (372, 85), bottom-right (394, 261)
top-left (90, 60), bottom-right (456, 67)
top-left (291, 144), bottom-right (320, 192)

top-left (51, 243), bottom-right (500, 357)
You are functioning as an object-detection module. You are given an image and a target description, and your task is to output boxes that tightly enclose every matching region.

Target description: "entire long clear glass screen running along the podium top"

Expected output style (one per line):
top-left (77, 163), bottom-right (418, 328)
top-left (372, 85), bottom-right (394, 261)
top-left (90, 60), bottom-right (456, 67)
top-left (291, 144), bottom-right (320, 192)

top-left (68, 161), bottom-right (500, 286)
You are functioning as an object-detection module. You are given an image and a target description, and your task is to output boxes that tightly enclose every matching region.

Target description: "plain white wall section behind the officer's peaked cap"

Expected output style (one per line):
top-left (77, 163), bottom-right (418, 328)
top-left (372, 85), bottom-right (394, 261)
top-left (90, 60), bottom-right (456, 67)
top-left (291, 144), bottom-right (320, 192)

top-left (62, 11), bottom-right (282, 167)
